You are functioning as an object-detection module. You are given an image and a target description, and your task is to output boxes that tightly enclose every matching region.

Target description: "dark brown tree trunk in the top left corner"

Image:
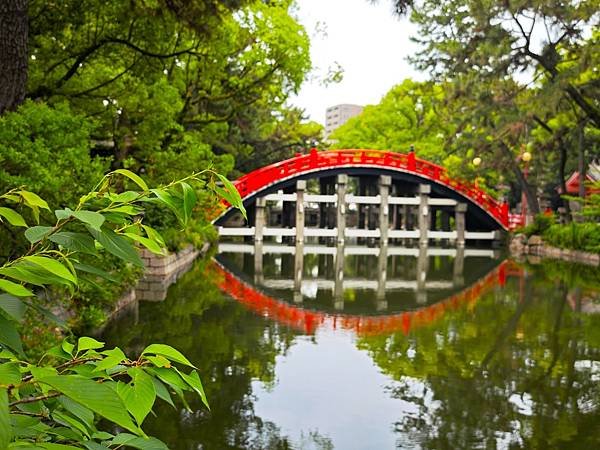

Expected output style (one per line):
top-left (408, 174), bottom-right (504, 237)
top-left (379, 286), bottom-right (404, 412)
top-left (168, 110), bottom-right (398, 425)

top-left (0, 0), bottom-right (28, 114)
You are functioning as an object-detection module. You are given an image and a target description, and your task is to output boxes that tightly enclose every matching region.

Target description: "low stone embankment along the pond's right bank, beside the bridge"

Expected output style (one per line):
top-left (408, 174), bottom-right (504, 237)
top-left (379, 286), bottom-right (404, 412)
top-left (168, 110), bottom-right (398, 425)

top-left (509, 234), bottom-right (600, 266)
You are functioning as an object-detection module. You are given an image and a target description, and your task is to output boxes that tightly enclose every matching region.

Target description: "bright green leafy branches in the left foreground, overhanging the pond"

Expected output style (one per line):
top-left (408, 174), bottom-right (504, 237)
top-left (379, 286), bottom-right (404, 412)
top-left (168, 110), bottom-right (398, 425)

top-left (0, 169), bottom-right (245, 450)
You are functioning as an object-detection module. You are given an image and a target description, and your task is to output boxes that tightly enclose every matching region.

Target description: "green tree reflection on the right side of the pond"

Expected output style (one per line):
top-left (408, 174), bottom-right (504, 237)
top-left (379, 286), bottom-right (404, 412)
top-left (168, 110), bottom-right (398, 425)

top-left (359, 277), bottom-right (600, 449)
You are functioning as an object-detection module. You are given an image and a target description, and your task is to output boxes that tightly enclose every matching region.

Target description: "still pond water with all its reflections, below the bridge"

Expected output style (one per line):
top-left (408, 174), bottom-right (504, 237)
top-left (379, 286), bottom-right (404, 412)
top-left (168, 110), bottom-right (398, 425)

top-left (104, 244), bottom-right (600, 450)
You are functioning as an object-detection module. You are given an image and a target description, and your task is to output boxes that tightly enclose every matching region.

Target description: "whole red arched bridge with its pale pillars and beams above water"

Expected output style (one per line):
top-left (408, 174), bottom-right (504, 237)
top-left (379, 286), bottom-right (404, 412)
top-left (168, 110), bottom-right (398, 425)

top-left (215, 149), bottom-right (509, 245)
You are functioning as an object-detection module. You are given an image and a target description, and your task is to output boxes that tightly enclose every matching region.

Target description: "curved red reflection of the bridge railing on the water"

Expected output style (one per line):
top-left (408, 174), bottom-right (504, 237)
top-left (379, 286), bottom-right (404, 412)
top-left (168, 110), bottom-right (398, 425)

top-left (214, 261), bottom-right (513, 335)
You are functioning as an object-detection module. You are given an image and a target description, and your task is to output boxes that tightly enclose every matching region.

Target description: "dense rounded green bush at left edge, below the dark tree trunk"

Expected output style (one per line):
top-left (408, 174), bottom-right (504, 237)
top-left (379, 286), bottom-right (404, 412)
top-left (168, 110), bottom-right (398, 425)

top-left (0, 101), bottom-right (108, 261)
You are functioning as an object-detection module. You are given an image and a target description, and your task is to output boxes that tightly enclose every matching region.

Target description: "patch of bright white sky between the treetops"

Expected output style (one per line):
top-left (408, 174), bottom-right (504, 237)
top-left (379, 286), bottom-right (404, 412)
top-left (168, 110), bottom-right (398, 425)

top-left (290, 0), bottom-right (426, 124)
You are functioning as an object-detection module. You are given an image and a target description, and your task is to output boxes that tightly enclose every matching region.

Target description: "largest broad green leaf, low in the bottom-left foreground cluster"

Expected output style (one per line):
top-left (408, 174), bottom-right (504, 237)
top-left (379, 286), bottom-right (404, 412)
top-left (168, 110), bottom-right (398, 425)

top-left (38, 375), bottom-right (142, 435)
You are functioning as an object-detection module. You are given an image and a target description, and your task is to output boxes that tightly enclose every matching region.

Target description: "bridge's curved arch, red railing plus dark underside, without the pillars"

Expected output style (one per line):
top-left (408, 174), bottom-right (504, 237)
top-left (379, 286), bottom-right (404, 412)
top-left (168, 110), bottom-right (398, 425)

top-left (214, 149), bottom-right (508, 230)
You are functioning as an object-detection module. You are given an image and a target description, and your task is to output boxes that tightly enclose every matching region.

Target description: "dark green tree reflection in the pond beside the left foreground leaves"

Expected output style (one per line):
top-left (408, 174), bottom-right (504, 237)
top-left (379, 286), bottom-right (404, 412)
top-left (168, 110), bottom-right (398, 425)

top-left (104, 261), bottom-right (304, 450)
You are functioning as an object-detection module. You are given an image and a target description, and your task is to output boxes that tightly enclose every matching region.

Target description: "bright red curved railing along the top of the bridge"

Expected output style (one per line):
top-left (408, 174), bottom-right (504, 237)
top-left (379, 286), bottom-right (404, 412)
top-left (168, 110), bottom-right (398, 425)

top-left (227, 149), bottom-right (508, 229)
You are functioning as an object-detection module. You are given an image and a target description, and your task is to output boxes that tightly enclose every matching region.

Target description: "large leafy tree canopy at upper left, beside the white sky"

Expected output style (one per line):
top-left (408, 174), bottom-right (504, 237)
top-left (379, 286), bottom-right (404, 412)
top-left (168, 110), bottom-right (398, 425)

top-left (28, 0), bottom-right (310, 175)
